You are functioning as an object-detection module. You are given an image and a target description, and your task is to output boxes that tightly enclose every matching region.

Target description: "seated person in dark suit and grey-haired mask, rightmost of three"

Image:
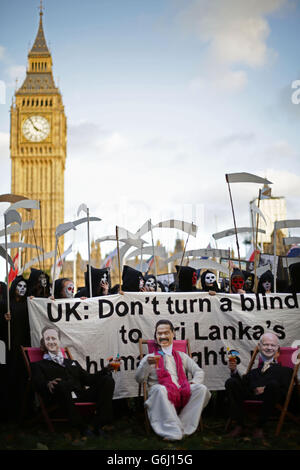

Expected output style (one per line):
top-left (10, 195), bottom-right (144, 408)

top-left (225, 333), bottom-right (293, 439)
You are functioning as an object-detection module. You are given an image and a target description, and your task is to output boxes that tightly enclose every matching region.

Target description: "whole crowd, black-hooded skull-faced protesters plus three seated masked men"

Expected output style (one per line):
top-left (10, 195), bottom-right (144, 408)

top-left (0, 263), bottom-right (300, 440)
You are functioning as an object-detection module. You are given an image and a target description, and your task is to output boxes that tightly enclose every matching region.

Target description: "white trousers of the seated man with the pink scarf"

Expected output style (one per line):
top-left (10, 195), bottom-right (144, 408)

top-left (145, 384), bottom-right (211, 440)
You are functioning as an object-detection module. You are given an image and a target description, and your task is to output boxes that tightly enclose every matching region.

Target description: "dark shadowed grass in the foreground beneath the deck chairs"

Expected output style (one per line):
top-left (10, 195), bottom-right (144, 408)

top-left (0, 399), bottom-right (300, 453)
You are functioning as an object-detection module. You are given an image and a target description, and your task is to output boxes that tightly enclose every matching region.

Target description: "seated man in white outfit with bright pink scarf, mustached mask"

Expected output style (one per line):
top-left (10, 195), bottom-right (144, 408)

top-left (136, 320), bottom-right (210, 440)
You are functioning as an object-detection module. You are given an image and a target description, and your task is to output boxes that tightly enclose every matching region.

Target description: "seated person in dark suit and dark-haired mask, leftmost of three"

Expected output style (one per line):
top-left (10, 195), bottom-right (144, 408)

top-left (31, 325), bottom-right (115, 435)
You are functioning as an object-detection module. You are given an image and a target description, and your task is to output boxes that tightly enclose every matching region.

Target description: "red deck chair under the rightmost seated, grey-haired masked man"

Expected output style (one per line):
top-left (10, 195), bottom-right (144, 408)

top-left (226, 346), bottom-right (300, 436)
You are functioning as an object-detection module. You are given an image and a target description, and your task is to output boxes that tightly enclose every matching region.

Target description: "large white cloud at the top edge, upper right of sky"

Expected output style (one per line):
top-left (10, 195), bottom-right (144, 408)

top-left (180, 0), bottom-right (288, 91)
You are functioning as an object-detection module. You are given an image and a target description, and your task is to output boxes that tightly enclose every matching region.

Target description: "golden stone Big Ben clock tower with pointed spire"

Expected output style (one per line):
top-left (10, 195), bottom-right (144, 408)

top-left (10, 6), bottom-right (67, 269)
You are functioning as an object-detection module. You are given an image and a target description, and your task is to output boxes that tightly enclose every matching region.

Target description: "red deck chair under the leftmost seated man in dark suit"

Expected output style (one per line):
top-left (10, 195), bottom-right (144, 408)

top-left (21, 346), bottom-right (95, 432)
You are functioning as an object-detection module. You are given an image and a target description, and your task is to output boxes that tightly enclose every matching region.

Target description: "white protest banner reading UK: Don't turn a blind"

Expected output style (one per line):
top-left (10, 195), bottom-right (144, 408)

top-left (28, 292), bottom-right (300, 398)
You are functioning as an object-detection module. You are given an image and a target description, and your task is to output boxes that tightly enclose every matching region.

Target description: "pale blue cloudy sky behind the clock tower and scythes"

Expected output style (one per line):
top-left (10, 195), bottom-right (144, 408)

top-left (0, 0), bottom-right (300, 274)
